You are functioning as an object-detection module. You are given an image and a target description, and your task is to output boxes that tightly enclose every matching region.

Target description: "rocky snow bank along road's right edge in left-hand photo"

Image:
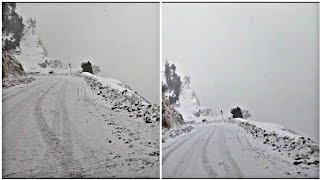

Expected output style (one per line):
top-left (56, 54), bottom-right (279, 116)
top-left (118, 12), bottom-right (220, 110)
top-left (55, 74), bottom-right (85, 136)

top-left (78, 72), bottom-right (160, 123)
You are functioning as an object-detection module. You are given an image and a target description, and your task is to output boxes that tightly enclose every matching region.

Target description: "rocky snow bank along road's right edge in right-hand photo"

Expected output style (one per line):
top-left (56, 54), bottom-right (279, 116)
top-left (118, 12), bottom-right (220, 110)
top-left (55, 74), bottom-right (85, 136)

top-left (228, 118), bottom-right (319, 168)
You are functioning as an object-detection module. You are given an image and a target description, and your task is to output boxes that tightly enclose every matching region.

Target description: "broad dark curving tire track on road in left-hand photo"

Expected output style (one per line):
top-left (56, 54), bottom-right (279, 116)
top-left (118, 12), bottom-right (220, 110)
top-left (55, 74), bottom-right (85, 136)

top-left (34, 82), bottom-right (83, 177)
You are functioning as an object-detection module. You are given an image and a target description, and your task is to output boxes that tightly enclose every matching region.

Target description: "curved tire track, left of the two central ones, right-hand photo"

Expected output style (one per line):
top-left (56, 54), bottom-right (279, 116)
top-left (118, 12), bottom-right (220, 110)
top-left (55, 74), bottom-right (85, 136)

top-left (201, 129), bottom-right (218, 178)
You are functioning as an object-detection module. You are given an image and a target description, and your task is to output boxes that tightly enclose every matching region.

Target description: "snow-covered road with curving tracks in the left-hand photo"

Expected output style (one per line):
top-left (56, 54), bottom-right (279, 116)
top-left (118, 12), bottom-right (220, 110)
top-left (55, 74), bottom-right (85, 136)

top-left (2, 76), bottom-right (159, 178)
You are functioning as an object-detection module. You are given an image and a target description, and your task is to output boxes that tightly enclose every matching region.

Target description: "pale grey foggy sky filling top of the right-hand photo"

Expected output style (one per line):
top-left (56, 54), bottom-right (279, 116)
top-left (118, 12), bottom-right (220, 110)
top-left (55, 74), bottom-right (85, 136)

top-left (162, 3), bottom-right (319, 142)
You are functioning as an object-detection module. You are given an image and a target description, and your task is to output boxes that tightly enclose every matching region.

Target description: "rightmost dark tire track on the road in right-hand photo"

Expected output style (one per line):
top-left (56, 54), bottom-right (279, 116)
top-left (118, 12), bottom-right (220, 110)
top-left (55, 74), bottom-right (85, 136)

top-left (219, 127), bottom-right (244, 178)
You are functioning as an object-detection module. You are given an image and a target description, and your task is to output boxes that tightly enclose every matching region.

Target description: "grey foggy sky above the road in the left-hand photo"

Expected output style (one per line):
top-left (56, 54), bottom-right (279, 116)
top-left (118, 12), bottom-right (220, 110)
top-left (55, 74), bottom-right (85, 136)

top-left (17, 3), bottom-right (159, 103)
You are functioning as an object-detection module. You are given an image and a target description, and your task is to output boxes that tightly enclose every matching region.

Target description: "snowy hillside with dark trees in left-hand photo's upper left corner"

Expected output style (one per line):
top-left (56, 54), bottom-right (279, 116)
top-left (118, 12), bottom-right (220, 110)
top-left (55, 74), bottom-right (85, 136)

top-left (2, 3), bottom-right (69, 87)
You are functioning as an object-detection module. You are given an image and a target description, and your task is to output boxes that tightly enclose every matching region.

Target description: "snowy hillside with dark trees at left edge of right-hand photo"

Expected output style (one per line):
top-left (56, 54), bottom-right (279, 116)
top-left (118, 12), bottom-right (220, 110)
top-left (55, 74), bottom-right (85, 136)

top-left (162, 62), bottom-right (213, 142)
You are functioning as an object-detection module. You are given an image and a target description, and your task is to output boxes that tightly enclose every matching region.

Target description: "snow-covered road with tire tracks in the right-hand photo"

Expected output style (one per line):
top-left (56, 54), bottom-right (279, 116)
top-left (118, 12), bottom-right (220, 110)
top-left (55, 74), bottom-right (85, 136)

top-left (162, 122), bottom-right (319, 178)
